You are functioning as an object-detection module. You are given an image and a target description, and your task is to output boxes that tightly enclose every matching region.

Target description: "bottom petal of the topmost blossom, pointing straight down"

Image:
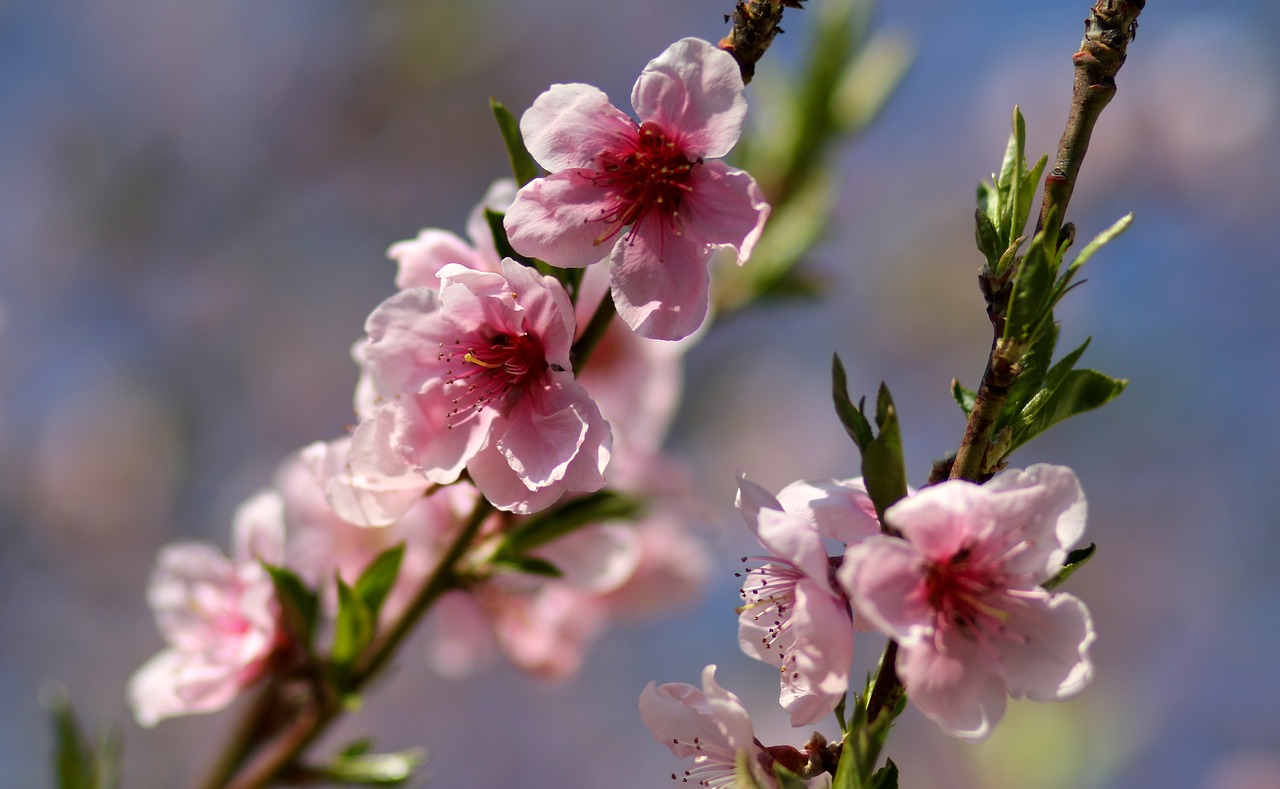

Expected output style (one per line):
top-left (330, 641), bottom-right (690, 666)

top-left (609, 222), bottom-right (710, 339)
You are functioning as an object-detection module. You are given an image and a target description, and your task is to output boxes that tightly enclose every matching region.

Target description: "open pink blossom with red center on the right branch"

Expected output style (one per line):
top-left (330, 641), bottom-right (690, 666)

top-left (838, 465), bottom-right (1094, 742)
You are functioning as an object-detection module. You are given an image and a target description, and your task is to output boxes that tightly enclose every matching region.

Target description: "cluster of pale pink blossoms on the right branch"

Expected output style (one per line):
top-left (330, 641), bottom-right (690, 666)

top-left (640, 465), bottom-right (1094, 786)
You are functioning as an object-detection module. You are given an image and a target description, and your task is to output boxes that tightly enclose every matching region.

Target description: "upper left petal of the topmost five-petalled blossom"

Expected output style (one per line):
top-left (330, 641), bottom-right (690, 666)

top-left (522, 82), bottom-right (636, 171)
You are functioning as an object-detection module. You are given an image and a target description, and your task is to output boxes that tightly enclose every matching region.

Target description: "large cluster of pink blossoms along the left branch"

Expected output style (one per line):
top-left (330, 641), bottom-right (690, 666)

top-left (129, 38), bottom-right (769, 725)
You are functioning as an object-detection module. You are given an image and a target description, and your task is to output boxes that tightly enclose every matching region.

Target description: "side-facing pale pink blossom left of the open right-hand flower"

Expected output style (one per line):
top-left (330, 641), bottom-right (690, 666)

top-left (737, 475), bottom-right (878, 726)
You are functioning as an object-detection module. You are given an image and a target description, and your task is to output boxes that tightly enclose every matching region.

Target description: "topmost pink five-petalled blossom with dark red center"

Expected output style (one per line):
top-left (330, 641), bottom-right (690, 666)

top-left (506, 38), bottom-right (769, 339)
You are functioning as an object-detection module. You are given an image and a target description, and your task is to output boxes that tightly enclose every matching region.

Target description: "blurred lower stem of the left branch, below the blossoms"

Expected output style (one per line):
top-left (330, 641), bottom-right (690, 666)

top-left (206, 498), bottom-right (493, 789)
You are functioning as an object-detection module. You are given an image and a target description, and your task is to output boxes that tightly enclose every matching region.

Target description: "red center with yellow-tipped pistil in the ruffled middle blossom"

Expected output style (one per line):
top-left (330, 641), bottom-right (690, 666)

top-left (435, 334), bottom-right (548, 429)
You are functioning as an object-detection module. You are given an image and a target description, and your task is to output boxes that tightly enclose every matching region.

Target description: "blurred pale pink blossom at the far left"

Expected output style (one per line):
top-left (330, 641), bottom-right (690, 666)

top-left (127, 492), bottom-right (283, 726)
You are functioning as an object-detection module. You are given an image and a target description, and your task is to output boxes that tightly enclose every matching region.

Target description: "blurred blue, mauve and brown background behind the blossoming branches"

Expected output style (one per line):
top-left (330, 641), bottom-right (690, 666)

top-left (0, 0), bottom-right (1280, 789)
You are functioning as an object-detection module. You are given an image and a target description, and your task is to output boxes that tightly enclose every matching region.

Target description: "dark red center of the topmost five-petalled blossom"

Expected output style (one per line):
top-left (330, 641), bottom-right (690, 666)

top-left (590, 120), bottom-right (703, 243)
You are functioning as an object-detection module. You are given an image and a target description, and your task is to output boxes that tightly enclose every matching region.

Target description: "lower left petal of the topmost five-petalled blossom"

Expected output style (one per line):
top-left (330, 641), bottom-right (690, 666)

top-left (503, 170), bottom-right (614, 269)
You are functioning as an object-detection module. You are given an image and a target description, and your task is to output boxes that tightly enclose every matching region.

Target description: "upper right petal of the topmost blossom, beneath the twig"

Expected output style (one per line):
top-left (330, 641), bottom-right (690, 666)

top-left (632, 38), bottom-right (746, 159)
